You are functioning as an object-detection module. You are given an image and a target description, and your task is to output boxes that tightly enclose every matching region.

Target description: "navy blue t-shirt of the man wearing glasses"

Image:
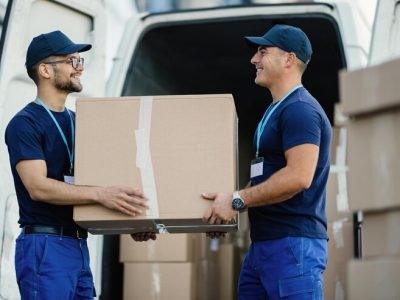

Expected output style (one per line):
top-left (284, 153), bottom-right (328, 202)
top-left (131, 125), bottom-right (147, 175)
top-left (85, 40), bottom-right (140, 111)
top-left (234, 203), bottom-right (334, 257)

top-left (5, 102), bottom-right (77, 228)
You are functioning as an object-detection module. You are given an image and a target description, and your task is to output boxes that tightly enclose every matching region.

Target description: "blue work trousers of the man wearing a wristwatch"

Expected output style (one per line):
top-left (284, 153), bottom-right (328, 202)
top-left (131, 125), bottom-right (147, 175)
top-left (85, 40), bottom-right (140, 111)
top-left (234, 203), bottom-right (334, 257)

top-left (238, 237), bottom-right (327, 300)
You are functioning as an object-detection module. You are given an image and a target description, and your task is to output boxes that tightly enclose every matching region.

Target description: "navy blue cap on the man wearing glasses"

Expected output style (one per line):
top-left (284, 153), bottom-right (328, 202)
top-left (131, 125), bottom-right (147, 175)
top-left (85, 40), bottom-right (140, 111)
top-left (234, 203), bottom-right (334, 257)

top-left (25, 30), bottom-right (92, 68)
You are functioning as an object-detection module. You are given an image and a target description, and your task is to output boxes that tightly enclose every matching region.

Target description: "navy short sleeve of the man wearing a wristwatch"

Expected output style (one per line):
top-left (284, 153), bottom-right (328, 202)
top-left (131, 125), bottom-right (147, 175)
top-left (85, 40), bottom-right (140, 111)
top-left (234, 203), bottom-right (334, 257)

top-left (281, 101), bottom-right (322, 151)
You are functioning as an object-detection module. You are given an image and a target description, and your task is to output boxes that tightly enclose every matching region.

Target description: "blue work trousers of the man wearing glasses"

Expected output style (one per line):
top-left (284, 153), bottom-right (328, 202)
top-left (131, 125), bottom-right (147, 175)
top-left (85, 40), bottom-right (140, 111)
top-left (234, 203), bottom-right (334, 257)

top-left (15, 232), bottom-right (95, 300)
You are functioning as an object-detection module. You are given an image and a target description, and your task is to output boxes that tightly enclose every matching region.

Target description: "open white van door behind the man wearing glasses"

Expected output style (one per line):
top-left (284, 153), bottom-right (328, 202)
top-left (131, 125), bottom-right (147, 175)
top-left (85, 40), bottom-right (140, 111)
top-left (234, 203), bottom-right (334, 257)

top-left (0, 0), bottom-right (106, 299)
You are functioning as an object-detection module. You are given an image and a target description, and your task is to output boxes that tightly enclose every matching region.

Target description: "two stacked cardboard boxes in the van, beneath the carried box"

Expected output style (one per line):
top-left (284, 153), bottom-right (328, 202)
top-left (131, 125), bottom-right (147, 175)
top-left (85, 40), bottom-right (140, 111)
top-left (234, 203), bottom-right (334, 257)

top-left (120, 234), bottom-right (196, 300)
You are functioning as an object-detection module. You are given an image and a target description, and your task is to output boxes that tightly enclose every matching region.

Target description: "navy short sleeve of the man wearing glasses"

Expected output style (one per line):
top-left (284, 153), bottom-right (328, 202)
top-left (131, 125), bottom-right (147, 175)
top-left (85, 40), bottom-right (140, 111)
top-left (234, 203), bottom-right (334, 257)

top-left (5, 116), bottom-right (45, 167)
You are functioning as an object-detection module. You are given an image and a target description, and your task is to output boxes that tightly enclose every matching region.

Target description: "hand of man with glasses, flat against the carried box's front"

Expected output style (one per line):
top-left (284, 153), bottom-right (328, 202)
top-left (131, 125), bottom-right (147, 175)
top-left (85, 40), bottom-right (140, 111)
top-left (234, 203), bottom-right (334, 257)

top-left (97, 186), bottom-right (149, 217)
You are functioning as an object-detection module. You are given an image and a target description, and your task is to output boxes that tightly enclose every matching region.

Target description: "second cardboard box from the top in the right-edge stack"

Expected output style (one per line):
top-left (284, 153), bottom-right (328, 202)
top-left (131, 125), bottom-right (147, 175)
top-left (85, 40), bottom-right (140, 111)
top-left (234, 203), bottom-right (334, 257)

top-left (348, 109), bottom-right (400, 211)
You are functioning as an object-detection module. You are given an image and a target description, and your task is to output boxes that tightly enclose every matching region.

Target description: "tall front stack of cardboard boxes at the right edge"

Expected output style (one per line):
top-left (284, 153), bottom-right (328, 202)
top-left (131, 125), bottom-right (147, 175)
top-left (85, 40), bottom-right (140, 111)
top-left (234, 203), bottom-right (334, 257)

top-left (340, 59), bottom-right (400, 300)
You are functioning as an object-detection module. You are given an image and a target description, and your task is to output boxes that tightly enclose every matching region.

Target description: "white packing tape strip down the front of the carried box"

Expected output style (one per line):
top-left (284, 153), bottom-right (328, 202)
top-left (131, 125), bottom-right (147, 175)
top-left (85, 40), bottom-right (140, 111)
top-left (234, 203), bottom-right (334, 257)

top-left (135, 96), bottom-right (159, 217)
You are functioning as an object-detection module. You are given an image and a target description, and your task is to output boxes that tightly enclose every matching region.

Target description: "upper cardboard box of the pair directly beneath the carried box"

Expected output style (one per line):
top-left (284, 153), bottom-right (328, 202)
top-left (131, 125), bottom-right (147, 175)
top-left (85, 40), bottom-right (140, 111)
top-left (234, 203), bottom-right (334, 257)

top-left (119, 233), bottom-right (199, 262)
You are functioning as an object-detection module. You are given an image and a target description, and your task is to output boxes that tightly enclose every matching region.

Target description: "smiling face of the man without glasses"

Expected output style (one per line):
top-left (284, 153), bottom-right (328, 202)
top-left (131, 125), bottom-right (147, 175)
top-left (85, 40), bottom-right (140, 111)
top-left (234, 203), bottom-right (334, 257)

top-left (250, 46), bottom-right (287, 88)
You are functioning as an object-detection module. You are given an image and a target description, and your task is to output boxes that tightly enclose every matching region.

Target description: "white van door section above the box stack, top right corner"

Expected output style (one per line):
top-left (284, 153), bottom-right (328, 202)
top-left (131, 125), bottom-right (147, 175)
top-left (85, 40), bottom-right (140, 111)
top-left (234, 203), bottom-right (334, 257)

top-left (369, 0), bottom-right (400, 65)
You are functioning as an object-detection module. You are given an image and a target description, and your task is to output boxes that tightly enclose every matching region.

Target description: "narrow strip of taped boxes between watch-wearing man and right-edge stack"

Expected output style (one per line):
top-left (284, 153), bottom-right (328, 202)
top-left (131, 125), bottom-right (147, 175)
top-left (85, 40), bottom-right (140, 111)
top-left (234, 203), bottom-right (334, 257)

top-left (324, 125), bottom-right (354, 300)
